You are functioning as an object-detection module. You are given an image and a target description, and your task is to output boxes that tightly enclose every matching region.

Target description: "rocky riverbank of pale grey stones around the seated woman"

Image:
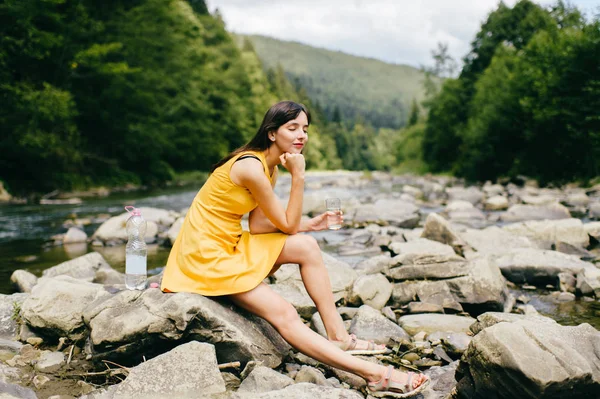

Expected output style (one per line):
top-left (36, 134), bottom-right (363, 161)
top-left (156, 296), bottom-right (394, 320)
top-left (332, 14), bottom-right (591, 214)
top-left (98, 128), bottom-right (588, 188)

top-left (0, 172), bottom-right (600, 399)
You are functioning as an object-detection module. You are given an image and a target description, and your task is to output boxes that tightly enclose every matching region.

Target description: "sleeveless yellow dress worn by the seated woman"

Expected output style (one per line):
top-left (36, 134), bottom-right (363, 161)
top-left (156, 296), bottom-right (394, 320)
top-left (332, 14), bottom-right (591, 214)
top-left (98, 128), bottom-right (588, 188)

top-left (161, 152), bottom-right (288, 296)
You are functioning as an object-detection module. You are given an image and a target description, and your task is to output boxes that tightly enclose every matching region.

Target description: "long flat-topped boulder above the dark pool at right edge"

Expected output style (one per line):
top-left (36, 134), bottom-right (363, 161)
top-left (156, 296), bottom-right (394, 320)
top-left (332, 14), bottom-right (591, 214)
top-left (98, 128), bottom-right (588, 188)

top-left (496, 248), bottom-right (595, 286)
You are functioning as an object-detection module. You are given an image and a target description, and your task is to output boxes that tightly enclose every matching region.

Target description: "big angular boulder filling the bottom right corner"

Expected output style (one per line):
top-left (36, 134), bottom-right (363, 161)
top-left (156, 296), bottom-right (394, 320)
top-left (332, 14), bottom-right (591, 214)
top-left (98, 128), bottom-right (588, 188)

top-left (456, 320), bottom-right (600, 399)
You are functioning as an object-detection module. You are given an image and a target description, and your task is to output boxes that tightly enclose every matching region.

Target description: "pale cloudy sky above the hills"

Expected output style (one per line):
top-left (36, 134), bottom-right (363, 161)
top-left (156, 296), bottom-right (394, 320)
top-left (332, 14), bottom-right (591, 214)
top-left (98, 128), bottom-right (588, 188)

top-left (206, 0), bottom-right (600, 67)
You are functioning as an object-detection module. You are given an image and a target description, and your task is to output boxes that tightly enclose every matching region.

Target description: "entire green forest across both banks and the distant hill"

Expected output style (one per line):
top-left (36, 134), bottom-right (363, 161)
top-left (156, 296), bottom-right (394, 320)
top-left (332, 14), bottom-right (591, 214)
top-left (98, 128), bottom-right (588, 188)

top-left (0, 0), bottom-right (600, 196)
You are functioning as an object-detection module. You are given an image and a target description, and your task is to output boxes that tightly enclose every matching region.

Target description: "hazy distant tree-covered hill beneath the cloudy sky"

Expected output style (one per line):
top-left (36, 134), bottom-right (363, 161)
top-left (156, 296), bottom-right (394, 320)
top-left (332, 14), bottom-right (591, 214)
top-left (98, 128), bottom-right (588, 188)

top-left (240, 35), bottom-right (423, 128)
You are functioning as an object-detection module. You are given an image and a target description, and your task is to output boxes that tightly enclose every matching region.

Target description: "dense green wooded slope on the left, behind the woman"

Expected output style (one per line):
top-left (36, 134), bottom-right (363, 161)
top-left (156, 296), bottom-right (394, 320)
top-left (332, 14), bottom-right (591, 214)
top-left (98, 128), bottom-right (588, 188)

top-left (0, 0), bottom-right (339, 194)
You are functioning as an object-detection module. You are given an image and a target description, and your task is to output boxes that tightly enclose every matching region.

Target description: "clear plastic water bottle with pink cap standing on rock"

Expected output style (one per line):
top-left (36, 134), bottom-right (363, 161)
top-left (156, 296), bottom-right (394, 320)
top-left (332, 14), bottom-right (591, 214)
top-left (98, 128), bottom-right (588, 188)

top-left (125, 206), bottom-right (148, 290)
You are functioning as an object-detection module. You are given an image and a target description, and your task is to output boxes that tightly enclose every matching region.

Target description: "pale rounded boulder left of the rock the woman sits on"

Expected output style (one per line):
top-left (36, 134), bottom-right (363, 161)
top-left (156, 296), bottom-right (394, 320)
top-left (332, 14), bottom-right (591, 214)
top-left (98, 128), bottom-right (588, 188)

top-left (21, 276), bottom-right (110, 340)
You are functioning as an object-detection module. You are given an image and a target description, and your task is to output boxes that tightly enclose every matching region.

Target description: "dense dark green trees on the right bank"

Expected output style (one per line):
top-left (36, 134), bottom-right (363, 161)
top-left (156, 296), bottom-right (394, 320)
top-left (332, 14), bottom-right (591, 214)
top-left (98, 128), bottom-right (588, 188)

top-left (417, 0), bottom-right (600, 182)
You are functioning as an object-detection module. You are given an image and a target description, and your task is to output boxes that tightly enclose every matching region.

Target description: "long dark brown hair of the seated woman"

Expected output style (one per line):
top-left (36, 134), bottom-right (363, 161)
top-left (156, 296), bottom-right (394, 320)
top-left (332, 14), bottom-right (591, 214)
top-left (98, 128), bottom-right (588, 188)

top-left (211, 101), bottom-right (310, 172)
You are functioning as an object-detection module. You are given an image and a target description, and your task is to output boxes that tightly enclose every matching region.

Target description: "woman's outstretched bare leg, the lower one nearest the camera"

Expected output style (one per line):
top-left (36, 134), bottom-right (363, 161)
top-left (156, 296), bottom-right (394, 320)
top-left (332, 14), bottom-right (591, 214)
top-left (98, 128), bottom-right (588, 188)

top-left (229, 283), bottom-right (426, 388)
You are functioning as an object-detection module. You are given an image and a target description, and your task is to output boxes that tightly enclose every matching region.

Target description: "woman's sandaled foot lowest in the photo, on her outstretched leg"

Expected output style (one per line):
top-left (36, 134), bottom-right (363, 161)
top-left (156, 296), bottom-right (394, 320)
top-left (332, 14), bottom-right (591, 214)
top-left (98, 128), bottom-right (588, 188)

top-left (367, 366), bottom-right (429, 398)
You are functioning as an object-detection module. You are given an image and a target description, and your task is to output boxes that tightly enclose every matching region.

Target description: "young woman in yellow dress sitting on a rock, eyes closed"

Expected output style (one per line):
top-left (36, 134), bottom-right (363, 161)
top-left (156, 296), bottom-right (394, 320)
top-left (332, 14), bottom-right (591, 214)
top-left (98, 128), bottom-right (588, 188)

top-left (161, 101), bottom-right (429, 397)
